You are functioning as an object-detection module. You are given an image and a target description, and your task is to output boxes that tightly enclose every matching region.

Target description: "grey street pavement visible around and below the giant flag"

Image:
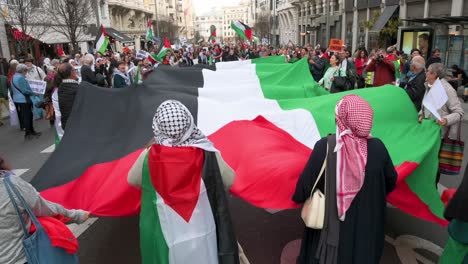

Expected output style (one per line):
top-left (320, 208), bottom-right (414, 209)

top-left (0, 95), bottom-right (468, 264)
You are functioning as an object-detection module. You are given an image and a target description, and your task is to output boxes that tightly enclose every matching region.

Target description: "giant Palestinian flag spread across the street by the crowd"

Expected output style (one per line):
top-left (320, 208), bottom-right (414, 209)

top-left (32, 57), bottom-right (446, 225)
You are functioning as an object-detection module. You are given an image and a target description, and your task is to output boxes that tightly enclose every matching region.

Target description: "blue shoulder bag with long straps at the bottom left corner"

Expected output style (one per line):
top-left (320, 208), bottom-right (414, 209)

top-left (4, 175), bottom-right (79, 264)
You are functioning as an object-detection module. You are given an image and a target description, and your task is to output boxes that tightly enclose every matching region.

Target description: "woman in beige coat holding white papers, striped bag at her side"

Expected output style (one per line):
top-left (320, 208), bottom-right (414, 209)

top-left (413, 63), bottom-right (464, 183)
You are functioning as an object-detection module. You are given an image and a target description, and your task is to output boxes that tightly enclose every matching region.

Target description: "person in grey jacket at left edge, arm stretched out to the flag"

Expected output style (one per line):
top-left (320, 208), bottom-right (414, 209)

top-left (0, 157), bottom-right (89, 264)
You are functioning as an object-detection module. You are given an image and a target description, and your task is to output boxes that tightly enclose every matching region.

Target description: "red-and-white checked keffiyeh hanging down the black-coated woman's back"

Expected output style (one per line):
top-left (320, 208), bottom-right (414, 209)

top-left (335, 95), bottom-right (374, 221)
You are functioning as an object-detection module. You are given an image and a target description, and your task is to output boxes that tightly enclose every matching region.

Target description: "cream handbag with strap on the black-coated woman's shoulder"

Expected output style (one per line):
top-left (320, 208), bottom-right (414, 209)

top-left (301, 144), bottom-right (328, 229)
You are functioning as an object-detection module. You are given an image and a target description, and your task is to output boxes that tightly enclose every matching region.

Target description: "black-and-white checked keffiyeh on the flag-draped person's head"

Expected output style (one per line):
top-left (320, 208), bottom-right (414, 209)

top-left (153, 100), bottom-right (217, 151)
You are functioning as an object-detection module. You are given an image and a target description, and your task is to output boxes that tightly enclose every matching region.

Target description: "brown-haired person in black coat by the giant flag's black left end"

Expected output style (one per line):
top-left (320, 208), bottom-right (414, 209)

top-left (55, 63), bottom-right (79, 130)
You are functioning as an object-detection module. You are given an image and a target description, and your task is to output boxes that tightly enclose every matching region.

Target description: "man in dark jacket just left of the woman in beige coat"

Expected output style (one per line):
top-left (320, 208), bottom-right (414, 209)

top-left (405, 56), bottom-right (426, 111)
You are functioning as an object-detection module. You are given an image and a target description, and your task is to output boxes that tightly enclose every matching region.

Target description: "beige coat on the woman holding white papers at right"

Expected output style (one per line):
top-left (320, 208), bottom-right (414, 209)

top-left (419, 79), bottom-right (464, 139)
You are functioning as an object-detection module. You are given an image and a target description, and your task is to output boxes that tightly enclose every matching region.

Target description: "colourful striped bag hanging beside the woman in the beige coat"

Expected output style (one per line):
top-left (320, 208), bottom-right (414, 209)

top-left (439, 117), bottom-right (465, 175)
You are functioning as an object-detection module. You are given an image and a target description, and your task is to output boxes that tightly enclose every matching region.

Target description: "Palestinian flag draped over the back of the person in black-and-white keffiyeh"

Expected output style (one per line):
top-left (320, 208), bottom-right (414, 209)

top-left (137, 145), bottom-right (239, 264)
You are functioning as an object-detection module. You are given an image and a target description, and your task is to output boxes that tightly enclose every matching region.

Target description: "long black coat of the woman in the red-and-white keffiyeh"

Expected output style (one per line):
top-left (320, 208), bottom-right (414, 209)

top-left (292, 138), bottom-right (397, 264)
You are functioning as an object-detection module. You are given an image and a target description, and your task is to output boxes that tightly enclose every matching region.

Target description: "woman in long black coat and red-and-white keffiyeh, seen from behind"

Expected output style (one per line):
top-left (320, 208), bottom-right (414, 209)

top-left (292, 95), bottom-right (397, 264)
